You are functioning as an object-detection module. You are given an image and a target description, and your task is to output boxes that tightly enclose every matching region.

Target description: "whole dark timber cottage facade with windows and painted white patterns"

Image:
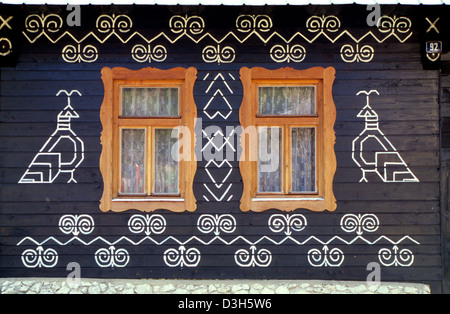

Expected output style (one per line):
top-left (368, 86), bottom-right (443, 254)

top-left (0, 1), bottom-right (450, 293)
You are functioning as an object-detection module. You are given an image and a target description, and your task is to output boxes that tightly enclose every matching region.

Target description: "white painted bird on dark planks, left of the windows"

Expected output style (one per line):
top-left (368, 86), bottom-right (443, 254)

top-left (19, 90), bottom-right (84, 183)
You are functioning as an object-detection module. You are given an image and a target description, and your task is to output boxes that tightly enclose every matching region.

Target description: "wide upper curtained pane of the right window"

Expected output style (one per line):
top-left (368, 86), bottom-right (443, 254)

top-left (259, 86), bottom-right (316, 115)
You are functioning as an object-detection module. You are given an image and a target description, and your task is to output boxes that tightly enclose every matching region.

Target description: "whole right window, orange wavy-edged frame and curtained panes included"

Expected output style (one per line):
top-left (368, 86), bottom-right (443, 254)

top-left (239, 68), bottom-right (336, 212)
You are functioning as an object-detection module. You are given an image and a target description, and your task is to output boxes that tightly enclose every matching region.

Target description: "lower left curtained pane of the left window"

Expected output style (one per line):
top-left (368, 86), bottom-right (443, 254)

top-left (120, 129), bottom-right (145, 194)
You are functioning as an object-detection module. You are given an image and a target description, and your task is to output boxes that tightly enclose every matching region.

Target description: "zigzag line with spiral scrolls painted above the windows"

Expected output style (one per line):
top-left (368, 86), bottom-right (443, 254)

top-left (21, 13), bottom-right (413, 64)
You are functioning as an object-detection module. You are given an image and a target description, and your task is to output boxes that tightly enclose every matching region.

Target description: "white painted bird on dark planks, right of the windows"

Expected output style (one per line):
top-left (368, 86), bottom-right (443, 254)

top-left (352, 90), bottom-right (419, 182)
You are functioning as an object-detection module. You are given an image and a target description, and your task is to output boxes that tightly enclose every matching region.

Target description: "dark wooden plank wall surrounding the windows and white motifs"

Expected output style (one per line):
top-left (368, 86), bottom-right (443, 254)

top-left (0, 6), bottom-right (448, 292)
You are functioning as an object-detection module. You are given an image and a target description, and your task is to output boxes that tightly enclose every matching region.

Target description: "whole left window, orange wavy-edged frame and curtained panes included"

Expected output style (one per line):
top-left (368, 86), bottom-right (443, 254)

top-left (100, 68), bottom-right (197, 212)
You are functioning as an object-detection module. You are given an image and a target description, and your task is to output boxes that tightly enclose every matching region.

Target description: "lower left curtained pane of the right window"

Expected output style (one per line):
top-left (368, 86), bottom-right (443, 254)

top-left (258, 127), bottom-right (283, 192)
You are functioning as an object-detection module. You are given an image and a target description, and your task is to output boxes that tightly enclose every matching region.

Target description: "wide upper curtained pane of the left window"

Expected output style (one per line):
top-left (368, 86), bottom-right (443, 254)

top-left (122, 87), bottom-right (178, 117)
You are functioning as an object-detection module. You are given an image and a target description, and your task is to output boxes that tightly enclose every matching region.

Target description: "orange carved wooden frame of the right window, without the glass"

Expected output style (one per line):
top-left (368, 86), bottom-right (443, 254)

top-left (239, 67), bottom-right (337, 212)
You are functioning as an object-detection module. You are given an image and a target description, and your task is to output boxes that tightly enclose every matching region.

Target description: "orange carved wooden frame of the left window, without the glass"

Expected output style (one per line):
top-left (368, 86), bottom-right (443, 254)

top-left (100, 67), bottom-right (197, 212)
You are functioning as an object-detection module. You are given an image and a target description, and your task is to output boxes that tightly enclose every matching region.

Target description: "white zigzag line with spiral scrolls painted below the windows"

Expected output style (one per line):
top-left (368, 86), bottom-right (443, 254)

top-left (17, 214), bottom-right (420, 268)
